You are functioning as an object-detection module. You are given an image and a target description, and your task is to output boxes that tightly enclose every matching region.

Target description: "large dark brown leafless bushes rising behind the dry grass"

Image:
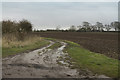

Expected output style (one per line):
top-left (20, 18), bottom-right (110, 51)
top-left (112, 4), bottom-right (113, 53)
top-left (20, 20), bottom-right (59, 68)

top-left (2, 19), bottom-right (32, 41)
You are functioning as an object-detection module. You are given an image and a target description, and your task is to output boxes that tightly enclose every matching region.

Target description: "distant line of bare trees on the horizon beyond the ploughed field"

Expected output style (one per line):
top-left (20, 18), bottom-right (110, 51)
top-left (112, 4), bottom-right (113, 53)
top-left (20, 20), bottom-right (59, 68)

top-left (34, 21), bottom-right (120, 32)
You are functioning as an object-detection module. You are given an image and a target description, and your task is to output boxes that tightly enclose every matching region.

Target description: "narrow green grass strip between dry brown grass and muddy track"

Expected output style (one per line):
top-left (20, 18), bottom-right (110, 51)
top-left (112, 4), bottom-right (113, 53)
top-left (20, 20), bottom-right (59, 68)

top-left (2, 39), bottom-right (50, 57)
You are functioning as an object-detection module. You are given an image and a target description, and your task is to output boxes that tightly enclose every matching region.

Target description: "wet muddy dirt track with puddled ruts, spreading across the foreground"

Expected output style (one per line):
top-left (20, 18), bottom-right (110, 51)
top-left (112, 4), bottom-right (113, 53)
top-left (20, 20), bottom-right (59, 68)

top-left (2, 41), bottom-right (108, 78)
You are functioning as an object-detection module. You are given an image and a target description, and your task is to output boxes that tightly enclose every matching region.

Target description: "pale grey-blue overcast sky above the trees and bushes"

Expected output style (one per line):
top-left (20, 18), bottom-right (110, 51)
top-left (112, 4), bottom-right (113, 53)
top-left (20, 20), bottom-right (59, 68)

top-left (2, 2), bottom-right (118, 29)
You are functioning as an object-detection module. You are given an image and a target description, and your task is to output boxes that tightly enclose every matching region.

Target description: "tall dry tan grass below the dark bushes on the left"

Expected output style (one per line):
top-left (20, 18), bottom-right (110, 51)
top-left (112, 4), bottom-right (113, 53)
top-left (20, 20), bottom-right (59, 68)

top-left (2, 34), bottom-right (42, 48)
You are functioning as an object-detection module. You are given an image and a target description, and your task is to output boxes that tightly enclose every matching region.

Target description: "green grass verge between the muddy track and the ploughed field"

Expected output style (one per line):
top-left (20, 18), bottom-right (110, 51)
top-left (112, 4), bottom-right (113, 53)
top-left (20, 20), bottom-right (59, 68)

top-left (64, 41), bottom-right (119, 78)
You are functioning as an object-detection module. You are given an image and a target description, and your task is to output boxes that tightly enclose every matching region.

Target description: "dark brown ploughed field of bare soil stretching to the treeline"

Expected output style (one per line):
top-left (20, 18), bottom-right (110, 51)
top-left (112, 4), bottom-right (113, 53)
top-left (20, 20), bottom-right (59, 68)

top-left (35, 32), bottom-right (118, 59)
